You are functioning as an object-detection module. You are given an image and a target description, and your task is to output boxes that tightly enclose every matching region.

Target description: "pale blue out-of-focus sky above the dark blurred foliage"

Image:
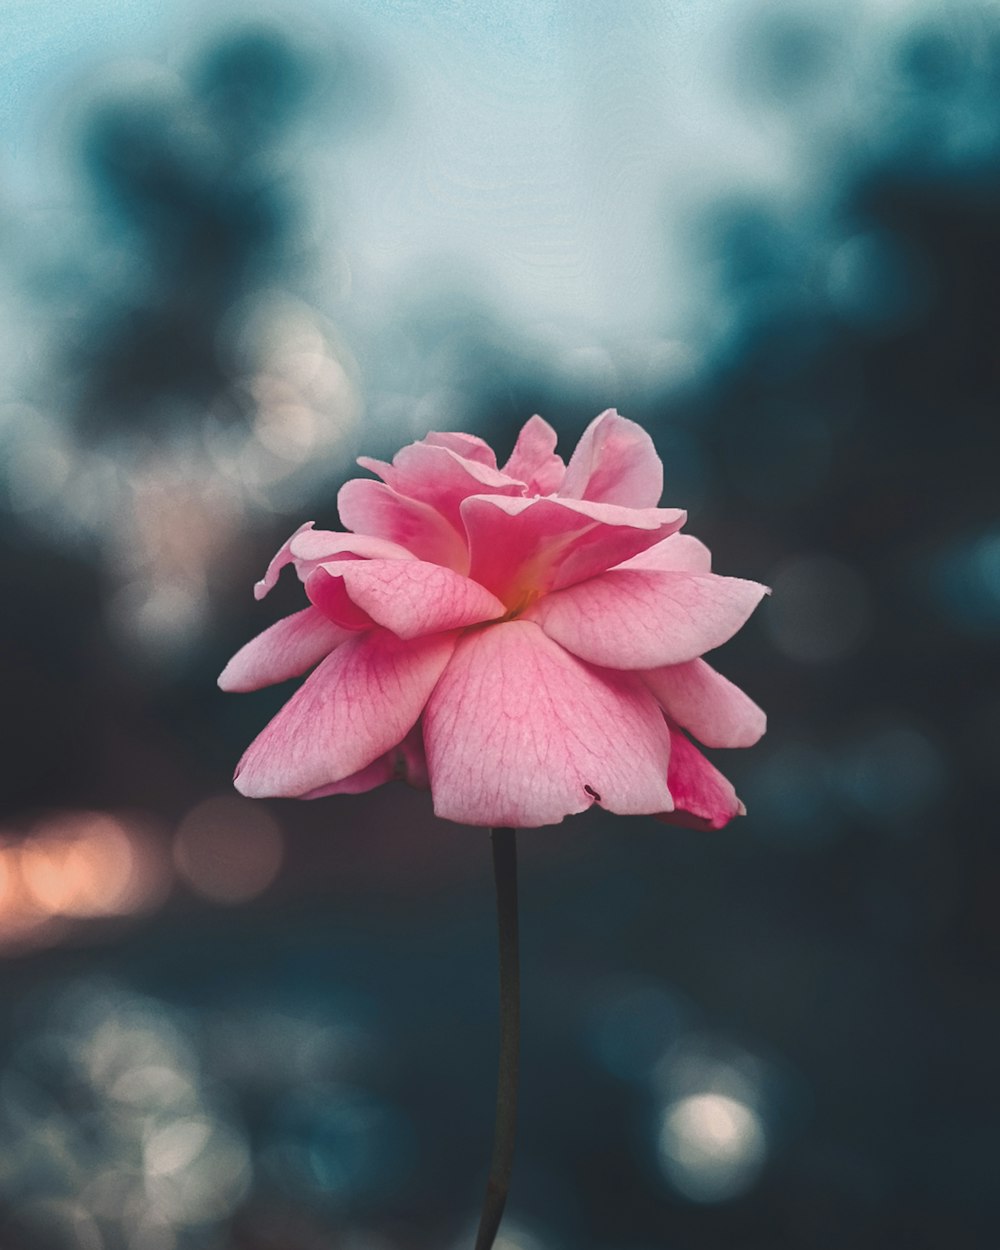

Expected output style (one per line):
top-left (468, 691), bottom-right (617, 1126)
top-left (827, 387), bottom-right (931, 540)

top-left (0, 0), bottom-right (940, 336)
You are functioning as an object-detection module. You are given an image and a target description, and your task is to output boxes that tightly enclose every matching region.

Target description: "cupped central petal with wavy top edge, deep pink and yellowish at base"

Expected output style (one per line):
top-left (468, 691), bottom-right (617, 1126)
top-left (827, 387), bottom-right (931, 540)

top-left (461, 495), bottom-right (685, 608)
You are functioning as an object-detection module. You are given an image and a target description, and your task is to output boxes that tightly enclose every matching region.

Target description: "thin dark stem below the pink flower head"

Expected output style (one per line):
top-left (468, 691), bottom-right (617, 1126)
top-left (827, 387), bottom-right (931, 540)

top-left (475, 829), bottom-right (521, 1250)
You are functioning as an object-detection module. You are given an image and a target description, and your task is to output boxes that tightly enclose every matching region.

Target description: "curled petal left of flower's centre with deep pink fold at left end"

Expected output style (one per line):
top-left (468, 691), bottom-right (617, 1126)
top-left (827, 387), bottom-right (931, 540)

top-left (306, 560), bottom-right (506, 638)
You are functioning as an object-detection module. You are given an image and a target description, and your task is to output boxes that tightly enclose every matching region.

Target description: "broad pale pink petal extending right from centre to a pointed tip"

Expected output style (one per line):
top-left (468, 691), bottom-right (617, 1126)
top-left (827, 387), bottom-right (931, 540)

top-left (526, 569), bottom-right (766, 669)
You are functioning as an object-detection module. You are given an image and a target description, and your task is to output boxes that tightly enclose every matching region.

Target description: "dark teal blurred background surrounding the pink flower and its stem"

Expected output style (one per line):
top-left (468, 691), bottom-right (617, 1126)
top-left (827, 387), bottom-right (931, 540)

top-left (0, 0), bottom-right (1000, 1250)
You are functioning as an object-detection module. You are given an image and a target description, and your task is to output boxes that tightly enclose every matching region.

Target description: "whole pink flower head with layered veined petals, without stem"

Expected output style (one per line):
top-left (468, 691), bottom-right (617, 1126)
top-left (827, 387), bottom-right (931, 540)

top-left (219, 411), bottom-right (766, 829)
